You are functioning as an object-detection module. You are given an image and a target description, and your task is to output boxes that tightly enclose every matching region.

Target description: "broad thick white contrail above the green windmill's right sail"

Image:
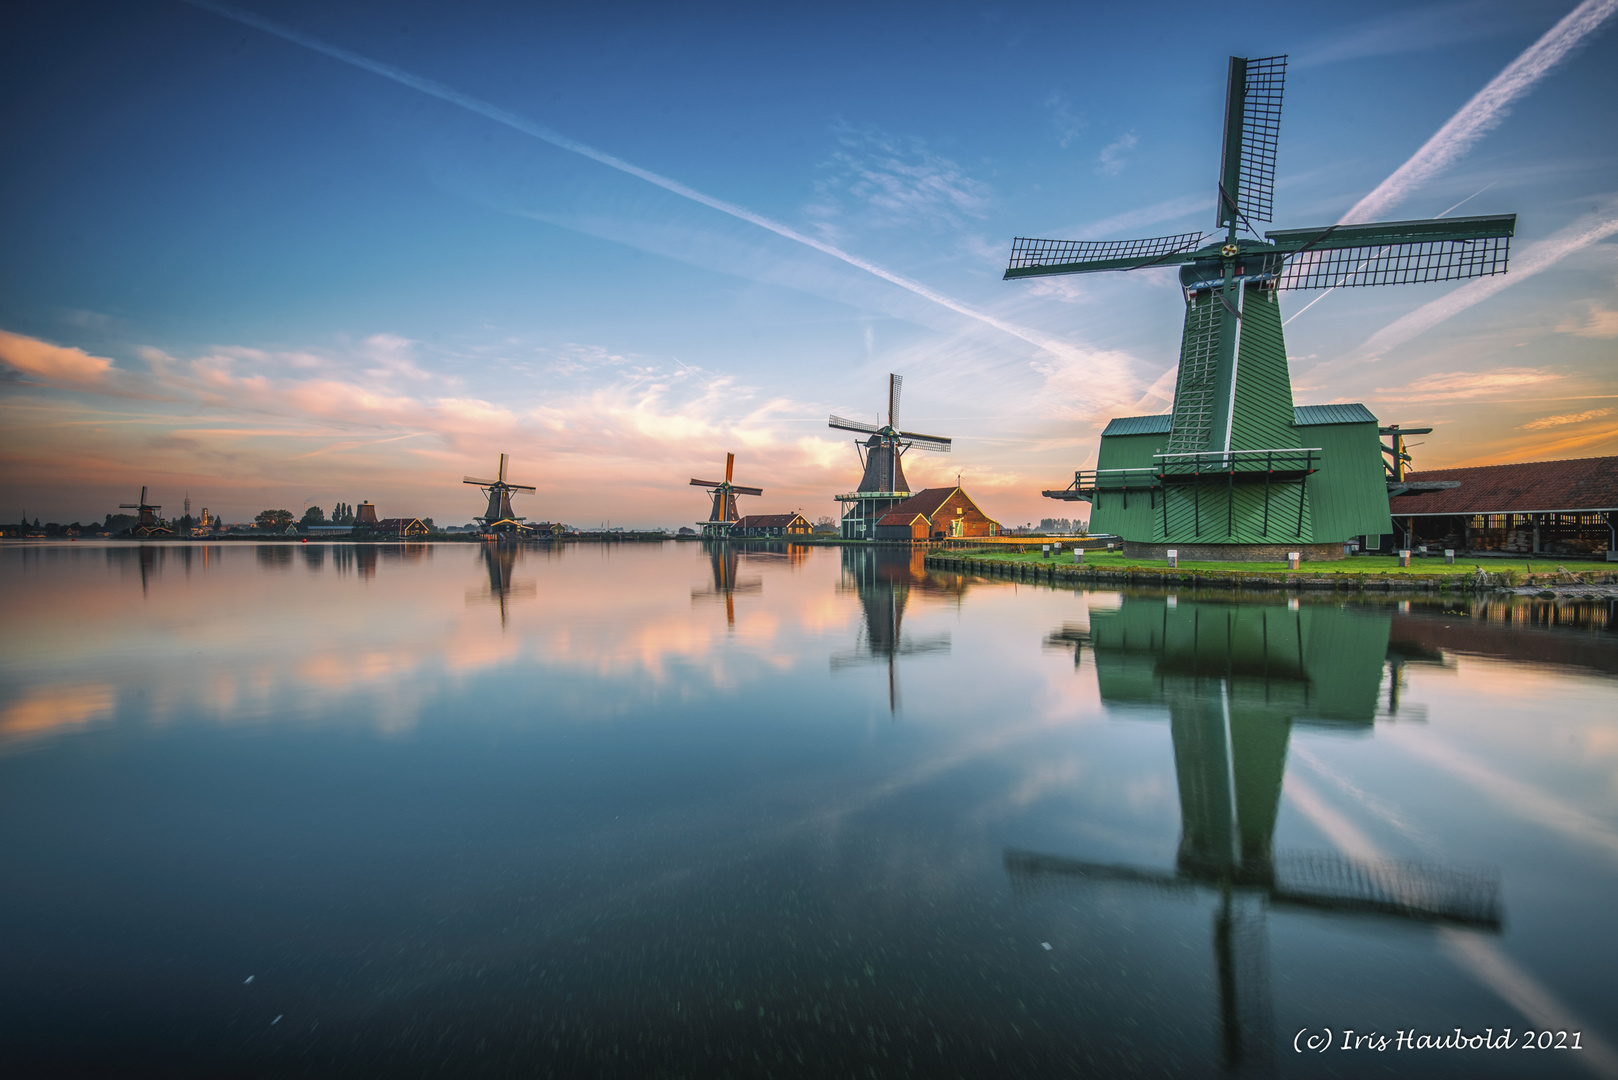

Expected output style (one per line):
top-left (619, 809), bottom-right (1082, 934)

top-left (1338, 0), bottom-right (1618, 225)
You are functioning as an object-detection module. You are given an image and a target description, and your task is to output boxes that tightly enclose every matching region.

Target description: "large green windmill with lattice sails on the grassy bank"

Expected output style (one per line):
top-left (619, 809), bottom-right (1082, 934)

top-left (1005, 57), bottom-right (1516, 559)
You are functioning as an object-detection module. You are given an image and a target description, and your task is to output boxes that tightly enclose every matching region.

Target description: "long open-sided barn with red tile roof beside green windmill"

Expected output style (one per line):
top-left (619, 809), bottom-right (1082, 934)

top-left (1372, 457), bottom-right (1618, 559)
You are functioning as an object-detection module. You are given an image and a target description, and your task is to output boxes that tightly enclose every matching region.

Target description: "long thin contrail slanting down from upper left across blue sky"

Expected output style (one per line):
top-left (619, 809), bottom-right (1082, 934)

top-left (183, 0), bottom-right (1080, 358)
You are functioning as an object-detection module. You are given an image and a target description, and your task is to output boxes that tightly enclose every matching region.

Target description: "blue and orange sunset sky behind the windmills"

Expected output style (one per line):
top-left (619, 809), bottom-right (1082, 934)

top-left (0, 0), bottom-right (1618, 525)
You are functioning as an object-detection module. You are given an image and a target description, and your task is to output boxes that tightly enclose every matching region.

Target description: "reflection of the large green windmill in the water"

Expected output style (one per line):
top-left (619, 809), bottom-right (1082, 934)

top-left (1005, 596), bottom-right (1500, 1072)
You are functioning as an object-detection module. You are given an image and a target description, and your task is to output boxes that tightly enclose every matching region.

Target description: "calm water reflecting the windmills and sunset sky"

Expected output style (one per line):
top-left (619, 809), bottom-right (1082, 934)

top-left (0, 544), bottom-right (1618, 1077)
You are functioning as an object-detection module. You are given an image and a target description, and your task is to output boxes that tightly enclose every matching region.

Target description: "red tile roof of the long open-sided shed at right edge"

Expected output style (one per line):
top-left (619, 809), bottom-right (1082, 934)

top-left (1388, 458), bottom-right (1618, 518)
